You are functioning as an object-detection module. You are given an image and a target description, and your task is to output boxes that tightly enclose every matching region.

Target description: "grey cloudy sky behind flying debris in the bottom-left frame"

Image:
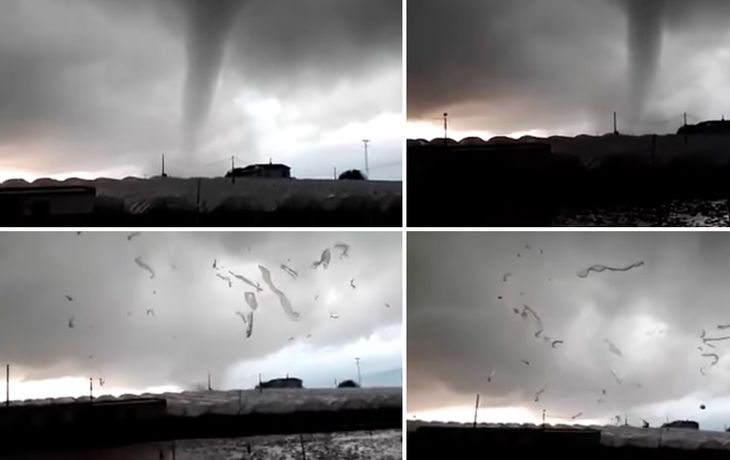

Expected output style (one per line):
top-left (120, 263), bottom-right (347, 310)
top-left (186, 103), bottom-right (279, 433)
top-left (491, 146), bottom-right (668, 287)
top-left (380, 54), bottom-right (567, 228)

top-left (0, 232), bottom-right (402, 399)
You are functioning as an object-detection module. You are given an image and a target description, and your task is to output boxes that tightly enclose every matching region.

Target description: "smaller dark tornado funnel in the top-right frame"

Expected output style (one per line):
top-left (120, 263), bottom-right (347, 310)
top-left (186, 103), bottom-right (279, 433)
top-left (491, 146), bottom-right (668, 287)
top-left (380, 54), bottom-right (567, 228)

top-left (624, 0), bottom-right (666, 121)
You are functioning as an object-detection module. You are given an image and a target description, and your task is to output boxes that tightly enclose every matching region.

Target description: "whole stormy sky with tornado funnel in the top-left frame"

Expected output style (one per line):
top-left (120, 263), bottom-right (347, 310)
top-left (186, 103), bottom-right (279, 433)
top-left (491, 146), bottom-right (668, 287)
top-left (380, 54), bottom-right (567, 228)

top-left (0, 0), bottom-right (402, 183)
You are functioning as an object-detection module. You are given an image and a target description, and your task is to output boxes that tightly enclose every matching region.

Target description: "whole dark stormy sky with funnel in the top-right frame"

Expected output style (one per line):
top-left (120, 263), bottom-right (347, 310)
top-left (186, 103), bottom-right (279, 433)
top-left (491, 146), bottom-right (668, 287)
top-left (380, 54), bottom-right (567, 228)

top-left (408, 0), bottom-right (730, 138)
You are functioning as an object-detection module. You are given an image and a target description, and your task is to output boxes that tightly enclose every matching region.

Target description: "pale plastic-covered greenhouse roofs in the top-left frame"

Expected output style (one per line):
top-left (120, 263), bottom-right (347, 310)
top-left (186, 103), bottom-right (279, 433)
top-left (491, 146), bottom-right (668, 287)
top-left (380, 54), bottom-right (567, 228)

top-left (0, 177), bottom-right (402, 214)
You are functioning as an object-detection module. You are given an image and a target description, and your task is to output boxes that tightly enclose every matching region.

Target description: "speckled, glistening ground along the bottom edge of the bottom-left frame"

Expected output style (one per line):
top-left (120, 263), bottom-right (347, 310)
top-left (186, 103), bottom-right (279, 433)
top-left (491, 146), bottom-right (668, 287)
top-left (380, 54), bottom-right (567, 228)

top-left (7, 430), bottom-right (402, 460)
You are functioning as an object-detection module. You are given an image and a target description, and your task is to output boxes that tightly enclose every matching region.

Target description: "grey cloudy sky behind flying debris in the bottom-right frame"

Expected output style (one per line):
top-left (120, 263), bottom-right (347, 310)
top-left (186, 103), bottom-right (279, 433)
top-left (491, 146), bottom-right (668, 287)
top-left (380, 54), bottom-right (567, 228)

top-left (407, 232), bottom-right (730, 430)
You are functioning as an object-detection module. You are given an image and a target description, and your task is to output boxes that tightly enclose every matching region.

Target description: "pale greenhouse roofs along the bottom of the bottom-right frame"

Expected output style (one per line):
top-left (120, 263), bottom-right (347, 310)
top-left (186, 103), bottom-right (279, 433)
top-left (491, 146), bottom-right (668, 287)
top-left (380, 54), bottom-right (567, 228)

top-left (407, 420), bottom-right (730, 450)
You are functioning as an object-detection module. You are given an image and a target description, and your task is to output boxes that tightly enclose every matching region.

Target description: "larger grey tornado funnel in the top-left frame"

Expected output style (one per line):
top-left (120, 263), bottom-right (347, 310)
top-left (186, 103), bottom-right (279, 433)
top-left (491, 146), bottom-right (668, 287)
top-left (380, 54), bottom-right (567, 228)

top-left (182, 0), bottom-right (248, 154)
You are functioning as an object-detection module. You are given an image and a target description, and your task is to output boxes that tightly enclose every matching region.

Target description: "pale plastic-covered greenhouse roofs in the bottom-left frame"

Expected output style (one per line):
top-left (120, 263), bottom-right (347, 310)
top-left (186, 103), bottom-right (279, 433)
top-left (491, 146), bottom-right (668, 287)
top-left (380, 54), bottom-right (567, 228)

top-left (11, 388), bottom-right (402, 417)
